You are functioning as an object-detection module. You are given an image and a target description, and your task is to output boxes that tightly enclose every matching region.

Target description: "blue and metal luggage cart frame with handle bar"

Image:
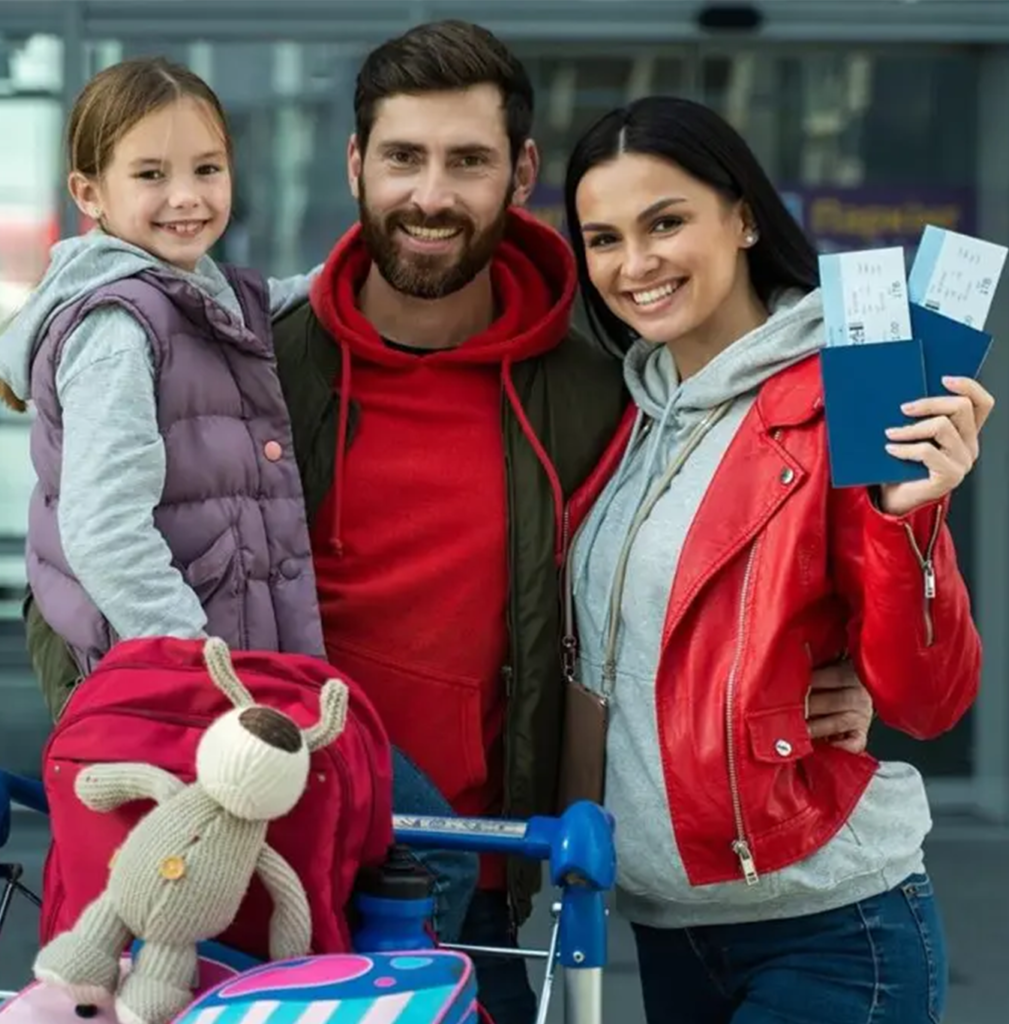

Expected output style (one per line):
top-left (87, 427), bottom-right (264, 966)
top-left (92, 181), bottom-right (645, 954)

top-left (0, 769), bottom-right (616, 1024)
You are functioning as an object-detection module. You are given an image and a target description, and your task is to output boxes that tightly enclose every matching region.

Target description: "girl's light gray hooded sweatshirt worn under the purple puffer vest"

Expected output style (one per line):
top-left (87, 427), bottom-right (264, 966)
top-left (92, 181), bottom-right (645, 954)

top-left (0, 235), bottom-right (319, 639)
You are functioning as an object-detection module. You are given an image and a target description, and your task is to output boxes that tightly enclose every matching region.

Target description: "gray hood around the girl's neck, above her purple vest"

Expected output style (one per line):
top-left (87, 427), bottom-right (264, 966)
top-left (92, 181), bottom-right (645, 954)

top-left (0, 228), bottom-right (234, 401)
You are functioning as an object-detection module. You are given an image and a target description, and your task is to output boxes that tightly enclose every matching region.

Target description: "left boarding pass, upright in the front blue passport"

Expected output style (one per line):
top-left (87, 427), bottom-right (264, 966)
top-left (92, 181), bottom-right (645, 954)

top-left (819, 247), bottom-right (911, 345)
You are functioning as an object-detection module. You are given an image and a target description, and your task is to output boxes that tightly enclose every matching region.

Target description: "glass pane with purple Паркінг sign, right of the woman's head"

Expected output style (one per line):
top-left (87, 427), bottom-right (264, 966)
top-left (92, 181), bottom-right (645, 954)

top-left (701, 48), bottom-right (977, 260)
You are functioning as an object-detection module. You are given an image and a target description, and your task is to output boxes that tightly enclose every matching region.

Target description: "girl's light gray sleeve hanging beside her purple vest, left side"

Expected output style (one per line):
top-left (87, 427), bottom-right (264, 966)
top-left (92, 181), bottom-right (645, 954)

top-left (56, 306), bottom-right (207, 640)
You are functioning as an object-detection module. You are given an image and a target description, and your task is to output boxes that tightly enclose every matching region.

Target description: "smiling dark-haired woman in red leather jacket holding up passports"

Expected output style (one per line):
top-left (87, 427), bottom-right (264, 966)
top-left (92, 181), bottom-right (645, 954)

top-left (565, 97), bottom-right (994, 1024)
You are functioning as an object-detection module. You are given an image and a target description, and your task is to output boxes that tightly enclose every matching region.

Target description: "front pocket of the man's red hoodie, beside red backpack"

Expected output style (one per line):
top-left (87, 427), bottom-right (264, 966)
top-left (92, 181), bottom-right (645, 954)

top-left (327, 641), bottom-right (487, 803)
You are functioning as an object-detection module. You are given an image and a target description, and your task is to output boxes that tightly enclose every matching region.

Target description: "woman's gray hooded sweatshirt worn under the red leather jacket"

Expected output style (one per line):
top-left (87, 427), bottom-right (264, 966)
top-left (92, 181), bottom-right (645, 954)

top-left (572, 292), bottom-right (931, 928)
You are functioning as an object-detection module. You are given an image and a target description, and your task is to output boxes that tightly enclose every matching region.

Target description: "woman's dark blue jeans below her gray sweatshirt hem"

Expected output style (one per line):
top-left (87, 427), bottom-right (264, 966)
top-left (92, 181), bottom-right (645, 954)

top-left (634, 874), bottom-right (948, 1024)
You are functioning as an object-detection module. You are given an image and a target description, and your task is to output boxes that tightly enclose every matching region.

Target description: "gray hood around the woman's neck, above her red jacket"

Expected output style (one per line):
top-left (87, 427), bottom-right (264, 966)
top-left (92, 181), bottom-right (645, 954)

top-left (624, 289), bottom-right (824, 422)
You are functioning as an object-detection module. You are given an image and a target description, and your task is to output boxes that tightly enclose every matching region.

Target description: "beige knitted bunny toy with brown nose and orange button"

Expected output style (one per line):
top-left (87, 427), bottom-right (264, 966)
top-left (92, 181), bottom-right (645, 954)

top-left (35, 638), bottom-right (348, 1024)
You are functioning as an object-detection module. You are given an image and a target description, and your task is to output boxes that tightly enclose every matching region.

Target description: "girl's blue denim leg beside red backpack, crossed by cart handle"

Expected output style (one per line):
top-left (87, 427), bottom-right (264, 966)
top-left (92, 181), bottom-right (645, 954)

top-left (392, 748), bottom-right (479, 942)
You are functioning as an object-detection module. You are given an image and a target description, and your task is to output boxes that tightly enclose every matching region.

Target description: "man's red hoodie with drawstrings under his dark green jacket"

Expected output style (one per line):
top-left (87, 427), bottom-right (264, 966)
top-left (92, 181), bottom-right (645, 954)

top-left (311, 211), bottom-right (576, 888)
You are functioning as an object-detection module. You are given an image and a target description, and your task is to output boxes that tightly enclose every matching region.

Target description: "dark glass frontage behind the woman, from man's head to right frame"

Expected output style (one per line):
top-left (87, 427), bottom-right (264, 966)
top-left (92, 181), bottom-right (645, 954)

top-left (519, 47), bottom-right (977, 243)
